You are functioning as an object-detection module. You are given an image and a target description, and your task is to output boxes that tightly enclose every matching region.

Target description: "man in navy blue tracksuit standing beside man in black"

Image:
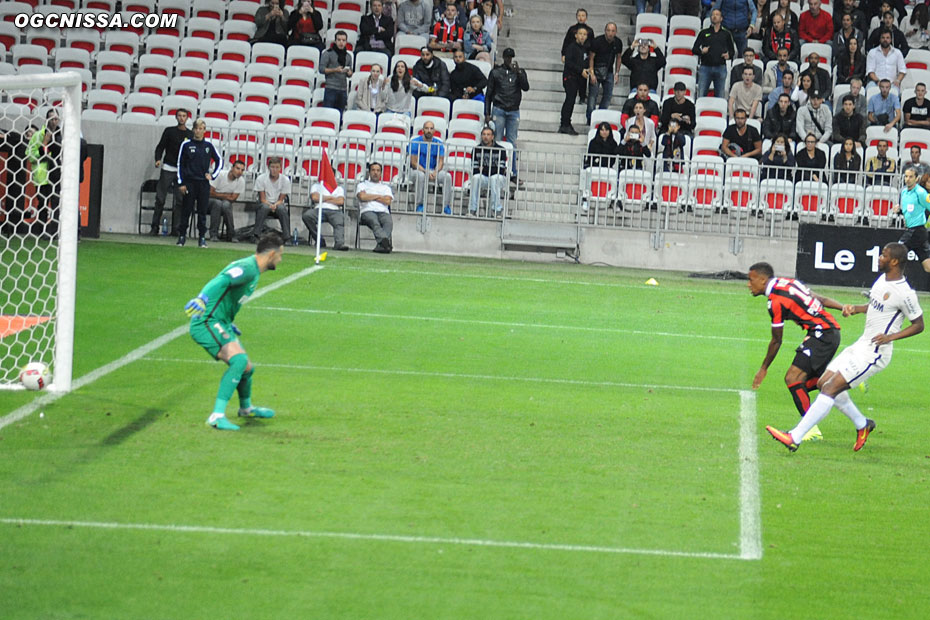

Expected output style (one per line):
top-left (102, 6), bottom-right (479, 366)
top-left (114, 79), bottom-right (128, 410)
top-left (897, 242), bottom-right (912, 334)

top-left (178, 119), bottom-right (223, 248)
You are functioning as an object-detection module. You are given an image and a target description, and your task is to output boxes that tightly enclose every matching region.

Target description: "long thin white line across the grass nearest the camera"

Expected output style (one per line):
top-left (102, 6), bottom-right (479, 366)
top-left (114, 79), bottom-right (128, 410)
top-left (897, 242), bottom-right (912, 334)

top-left (0, 518), bottom-right (759, 560)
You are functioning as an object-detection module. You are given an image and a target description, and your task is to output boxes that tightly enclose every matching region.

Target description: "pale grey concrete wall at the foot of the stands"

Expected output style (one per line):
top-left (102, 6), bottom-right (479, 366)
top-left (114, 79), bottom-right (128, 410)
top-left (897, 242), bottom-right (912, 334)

top-left (82, 122), bottom-right (797, 272)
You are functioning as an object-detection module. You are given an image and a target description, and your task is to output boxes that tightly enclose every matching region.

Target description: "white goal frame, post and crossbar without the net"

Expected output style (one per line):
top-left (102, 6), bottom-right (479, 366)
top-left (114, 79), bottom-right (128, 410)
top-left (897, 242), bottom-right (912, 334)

top-left (0, 71), bottom-right (81, 392)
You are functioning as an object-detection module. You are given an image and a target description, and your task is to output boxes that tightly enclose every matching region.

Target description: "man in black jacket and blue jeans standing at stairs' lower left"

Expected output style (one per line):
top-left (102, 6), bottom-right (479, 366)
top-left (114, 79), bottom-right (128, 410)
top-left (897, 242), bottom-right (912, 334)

top-left (484, 47), bottom-right (530, 180)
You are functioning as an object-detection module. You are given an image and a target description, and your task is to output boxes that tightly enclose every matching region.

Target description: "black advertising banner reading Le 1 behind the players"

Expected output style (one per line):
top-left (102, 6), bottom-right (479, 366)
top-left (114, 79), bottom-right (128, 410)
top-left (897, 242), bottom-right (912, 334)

top-left (792, 224), bottom-right (930, 291)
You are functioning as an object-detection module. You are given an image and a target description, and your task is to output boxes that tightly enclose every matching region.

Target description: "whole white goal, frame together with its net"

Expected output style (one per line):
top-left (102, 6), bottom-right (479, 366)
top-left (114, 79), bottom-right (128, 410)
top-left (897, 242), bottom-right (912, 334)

top-left (0, 73), bottom-right (81, 391)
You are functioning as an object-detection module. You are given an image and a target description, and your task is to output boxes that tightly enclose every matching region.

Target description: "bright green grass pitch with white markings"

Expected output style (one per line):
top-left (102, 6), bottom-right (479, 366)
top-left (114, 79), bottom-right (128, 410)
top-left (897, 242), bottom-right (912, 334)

top-left (0, 242), bottom-right (930, 620)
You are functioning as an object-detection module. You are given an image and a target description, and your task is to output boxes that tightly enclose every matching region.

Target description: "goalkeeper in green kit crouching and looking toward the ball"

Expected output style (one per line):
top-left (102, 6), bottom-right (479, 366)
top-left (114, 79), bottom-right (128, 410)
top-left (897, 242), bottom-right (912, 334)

top-left (184, 232), bottom-right (284, 431)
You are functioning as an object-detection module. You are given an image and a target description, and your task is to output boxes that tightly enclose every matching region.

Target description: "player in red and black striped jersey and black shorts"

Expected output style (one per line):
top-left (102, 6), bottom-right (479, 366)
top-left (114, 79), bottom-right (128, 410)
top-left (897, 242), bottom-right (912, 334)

top-left (749, 263), bottom-right (843, 437)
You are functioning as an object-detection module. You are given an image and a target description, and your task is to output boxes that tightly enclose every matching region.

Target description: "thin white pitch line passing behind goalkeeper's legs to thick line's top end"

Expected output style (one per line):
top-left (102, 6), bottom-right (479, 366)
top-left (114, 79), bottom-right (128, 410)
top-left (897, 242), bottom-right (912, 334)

top-left (144, 357), bottom-right (740, 394)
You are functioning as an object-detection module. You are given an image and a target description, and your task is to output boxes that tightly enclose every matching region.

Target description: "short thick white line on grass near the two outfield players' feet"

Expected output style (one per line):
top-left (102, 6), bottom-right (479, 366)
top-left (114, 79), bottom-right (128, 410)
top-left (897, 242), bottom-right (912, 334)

top-left (739, 390), bottom-right (762, 560)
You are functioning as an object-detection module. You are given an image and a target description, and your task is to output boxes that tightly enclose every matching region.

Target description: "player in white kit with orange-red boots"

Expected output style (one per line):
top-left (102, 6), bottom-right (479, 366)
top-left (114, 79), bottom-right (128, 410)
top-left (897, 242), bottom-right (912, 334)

top-left (765, 243), bottom-right (924, 452)
